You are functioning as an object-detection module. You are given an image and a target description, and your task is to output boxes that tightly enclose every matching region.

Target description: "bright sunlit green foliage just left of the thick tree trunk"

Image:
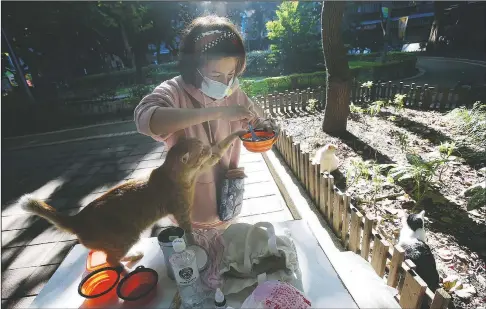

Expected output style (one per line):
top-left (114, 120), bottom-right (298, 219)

top-left (266, 1), bottom-right (322, 74)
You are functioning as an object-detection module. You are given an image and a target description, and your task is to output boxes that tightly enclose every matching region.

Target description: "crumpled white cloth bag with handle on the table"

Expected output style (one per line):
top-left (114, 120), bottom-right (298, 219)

top-left (220, 222), bottom-right (300, 295)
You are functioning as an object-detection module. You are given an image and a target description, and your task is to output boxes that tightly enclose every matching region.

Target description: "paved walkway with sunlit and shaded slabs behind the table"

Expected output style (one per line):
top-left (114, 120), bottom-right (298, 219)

top-left (1, 134), bottom-right (293, 308)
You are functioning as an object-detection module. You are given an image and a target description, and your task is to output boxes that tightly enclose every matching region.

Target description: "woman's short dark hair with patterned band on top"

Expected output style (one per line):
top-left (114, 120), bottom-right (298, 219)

top-left (179, 15), bottom-right (246, 88)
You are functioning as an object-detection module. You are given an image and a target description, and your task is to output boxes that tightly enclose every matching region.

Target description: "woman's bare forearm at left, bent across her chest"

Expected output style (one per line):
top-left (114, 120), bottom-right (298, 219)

top-left (150, 107), bottom-right (222, 135)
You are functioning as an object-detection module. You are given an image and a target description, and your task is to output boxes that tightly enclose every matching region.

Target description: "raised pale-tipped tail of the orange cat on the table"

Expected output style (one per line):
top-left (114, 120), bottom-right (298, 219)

top-left (19, 194), bottom-right (76, 234)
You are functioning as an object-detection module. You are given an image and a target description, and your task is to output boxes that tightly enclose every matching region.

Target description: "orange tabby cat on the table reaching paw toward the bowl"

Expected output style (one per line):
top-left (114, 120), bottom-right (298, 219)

top-left (20, 130), bottom-right (246, 265)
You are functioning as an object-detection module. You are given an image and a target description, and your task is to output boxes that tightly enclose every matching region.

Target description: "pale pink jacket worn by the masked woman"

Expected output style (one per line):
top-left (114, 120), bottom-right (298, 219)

top-left (134, 76), bottom-right (261, 228)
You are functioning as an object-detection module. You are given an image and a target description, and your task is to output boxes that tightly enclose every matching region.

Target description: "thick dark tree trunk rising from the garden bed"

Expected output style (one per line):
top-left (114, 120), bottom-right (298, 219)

top-left (321, 1), bottom-right (351, 135)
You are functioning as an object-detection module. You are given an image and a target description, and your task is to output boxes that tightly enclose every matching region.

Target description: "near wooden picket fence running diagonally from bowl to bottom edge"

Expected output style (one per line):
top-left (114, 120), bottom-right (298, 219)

top-left (272, 130), bottom-right (451, 309)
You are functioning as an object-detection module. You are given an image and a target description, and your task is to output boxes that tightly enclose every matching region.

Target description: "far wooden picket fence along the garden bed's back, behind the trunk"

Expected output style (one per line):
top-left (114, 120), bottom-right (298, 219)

top-left (253, 81), bottom-right (486, 116)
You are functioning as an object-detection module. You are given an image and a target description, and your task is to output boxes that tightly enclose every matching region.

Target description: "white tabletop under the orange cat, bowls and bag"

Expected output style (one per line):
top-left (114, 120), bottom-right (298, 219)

top-left (30, 220), bottom-right (358, 308)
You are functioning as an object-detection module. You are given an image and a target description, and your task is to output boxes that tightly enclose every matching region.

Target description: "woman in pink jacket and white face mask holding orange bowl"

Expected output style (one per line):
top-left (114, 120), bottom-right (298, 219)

top-left (134, 16), bottom-right (276, 228)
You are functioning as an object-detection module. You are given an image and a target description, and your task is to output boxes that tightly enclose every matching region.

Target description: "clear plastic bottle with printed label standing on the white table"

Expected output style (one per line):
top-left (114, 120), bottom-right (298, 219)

top-left (169, 238), bottom-right (204, 309)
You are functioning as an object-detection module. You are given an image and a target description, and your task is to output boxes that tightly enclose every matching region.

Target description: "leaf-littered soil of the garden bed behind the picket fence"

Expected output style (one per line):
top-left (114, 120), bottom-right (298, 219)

top-left (278, 109), bottom-right (486, 309)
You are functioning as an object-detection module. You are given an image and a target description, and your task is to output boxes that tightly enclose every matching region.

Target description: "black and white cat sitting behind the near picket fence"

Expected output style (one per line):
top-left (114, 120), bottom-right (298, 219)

top-left (398, 210), bottom-right (439, 292)
